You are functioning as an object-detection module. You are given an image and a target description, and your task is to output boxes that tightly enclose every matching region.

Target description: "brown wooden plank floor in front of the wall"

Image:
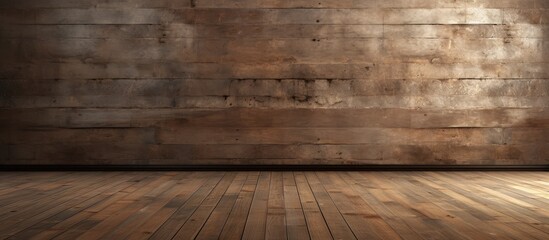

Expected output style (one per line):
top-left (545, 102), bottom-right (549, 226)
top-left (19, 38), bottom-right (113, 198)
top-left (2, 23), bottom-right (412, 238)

top-left (0, 172), bottom-right (549, 240)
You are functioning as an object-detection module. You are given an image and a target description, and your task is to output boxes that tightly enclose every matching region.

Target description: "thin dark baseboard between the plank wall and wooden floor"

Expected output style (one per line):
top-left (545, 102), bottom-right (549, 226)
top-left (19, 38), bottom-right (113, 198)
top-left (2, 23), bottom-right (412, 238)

top-left (0, 165), bottom-right (549, 171)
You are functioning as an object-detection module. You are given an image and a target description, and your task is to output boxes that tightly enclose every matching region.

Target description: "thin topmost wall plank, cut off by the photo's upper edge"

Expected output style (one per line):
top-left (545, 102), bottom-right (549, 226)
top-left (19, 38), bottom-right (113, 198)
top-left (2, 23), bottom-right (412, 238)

top-left (0, 0), bottom-right (548, 8)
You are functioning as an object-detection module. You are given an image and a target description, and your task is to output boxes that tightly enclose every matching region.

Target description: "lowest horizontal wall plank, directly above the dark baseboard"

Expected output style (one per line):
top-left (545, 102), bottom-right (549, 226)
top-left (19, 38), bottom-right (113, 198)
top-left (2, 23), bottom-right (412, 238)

top-left (2, 143), bottom-right (548, 165)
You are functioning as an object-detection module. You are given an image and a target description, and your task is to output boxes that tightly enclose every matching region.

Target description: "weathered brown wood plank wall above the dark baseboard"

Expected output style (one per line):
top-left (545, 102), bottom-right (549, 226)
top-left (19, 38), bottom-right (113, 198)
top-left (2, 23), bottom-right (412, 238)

top-left (0, 0), bottom-right (549, 165)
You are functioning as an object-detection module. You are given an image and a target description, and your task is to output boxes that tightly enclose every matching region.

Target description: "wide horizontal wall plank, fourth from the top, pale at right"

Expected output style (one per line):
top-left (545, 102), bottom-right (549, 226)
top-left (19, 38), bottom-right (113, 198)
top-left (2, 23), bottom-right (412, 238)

top-left (0, 38), bottom-right (549, 64)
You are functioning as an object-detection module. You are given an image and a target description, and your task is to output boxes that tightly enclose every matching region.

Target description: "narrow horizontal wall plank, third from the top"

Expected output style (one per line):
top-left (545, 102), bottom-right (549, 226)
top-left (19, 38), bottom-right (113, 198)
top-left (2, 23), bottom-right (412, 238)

top-left (0, 23), bottom-right (549, 41)
